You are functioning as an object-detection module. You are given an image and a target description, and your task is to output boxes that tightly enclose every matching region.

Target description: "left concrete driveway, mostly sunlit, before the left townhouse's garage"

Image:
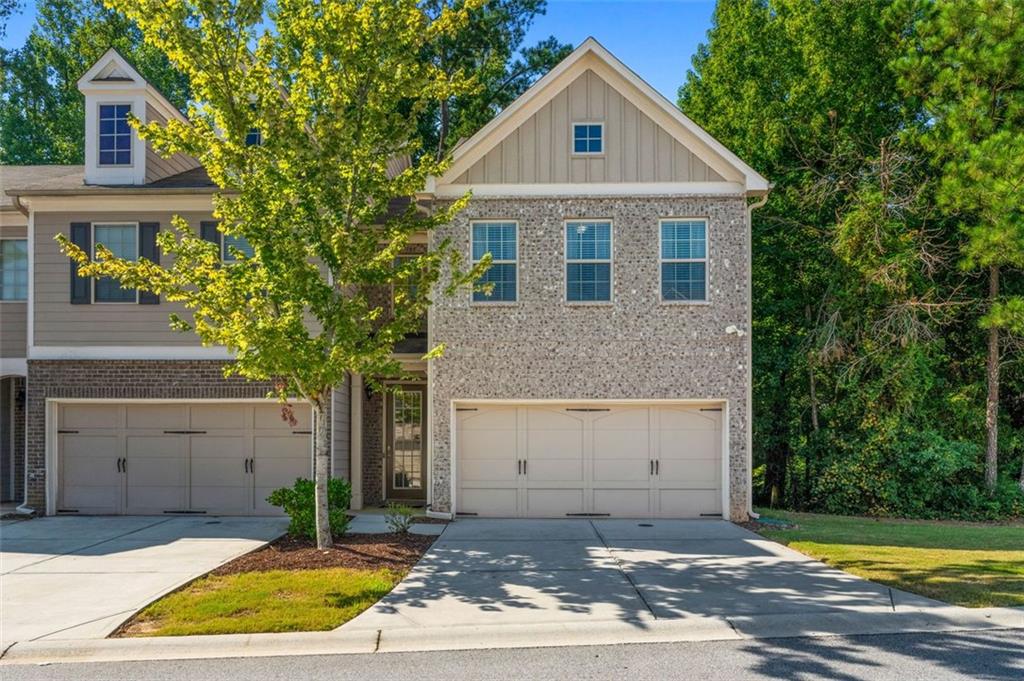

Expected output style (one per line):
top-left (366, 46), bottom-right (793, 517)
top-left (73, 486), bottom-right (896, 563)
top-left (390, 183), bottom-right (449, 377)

top-left (0, 516), bottom-right (288, 650)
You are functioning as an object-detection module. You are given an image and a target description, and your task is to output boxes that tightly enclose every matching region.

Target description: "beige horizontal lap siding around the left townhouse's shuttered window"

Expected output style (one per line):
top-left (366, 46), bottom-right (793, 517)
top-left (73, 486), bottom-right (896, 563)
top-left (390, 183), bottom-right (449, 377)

top-left (33, 211), bottom-right (210, 346)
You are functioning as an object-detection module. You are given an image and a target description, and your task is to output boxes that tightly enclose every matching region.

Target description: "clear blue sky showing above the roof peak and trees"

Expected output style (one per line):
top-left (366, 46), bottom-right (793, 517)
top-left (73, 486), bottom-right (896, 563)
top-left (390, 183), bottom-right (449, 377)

top-left (3, 0), bottom-right (715, 101)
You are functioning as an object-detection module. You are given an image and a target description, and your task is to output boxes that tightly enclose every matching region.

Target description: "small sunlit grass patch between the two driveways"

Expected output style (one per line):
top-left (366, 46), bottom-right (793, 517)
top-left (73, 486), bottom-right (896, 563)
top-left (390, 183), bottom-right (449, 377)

top-left (124, 567), bottom-right (401, 636)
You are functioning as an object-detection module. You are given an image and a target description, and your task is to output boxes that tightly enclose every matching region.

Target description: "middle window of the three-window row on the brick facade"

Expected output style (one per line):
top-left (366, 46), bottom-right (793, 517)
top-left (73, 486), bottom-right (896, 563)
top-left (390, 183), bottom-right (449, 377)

top-left (565, 222), bottom-right (611, 302)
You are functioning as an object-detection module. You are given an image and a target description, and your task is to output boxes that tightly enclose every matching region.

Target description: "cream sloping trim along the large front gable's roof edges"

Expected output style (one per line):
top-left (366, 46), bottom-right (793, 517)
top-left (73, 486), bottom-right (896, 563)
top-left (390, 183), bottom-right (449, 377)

top-left (434, 38), bottom-right (770, 194)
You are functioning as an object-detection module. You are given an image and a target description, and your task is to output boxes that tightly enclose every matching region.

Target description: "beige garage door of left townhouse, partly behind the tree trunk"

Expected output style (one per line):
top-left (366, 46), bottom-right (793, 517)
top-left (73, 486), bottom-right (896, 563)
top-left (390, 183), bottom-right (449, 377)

top-left (57, 402), bottom-right (311, 515)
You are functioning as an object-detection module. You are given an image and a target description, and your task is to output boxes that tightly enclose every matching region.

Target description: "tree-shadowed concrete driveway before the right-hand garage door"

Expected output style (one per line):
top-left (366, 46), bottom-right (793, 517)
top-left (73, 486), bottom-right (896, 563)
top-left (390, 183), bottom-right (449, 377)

top-left (342, 519), bottom-right (941, 630)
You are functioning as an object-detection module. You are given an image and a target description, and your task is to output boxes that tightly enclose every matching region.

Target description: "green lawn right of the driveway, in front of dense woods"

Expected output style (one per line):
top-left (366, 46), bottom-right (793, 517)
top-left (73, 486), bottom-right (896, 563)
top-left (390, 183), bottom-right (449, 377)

top-left (759, 509), bottom-right (1024, 607)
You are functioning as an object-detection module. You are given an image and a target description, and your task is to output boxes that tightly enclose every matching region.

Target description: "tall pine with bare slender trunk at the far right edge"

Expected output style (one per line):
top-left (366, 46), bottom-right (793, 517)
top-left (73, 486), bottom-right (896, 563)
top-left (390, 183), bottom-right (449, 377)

top-left (897, 0), bottom-right (1024, 492)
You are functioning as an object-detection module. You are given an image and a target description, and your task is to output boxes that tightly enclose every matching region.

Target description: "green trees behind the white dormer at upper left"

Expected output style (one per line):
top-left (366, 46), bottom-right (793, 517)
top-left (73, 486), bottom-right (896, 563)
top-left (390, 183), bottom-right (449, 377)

top-left (0, 0), bottom-right (189, 165)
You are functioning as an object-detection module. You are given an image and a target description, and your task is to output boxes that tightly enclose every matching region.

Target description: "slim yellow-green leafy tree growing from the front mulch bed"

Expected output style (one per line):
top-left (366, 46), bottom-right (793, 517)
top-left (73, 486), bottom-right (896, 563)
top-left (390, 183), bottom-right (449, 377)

top-left (58, 0), bottom-right (486, 548)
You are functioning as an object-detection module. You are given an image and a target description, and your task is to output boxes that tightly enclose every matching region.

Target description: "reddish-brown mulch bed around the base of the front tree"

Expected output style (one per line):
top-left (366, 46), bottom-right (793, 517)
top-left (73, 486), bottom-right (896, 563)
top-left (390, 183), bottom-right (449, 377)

top-left (211, 535), bottom-right (437, 576)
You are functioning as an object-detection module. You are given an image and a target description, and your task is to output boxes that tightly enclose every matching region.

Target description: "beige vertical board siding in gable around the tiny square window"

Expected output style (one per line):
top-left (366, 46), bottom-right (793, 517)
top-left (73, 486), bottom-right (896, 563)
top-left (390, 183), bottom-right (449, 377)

top-left (456, 71), bottom-right (722, 184)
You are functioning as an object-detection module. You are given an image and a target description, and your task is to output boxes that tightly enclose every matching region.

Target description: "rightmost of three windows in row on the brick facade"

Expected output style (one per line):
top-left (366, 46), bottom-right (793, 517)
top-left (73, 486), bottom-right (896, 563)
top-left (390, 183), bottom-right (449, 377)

top-left (662, 220), bottom-right (708, 301)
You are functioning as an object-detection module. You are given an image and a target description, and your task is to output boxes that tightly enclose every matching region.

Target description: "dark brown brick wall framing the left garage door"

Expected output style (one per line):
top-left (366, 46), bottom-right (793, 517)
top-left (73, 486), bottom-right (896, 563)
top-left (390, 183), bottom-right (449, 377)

top-left (26, 359), bottom-right (347, 513)
